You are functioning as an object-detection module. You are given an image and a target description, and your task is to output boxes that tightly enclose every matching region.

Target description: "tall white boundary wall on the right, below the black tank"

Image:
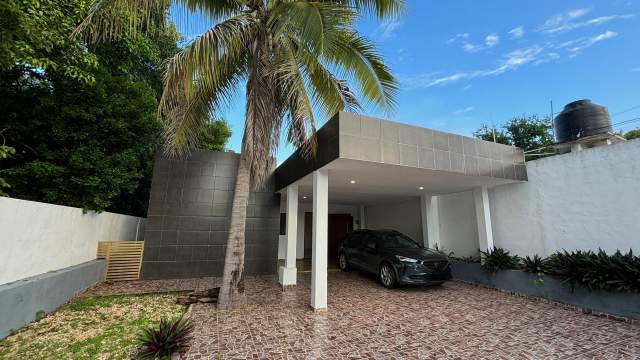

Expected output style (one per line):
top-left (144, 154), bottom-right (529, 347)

top-left (490, 140), bottom-right (640, 255)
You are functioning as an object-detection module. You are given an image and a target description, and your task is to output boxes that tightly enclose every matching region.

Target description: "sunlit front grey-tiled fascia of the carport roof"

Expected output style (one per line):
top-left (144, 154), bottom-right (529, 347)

top-left (339, 112), bottom-right (527, 181)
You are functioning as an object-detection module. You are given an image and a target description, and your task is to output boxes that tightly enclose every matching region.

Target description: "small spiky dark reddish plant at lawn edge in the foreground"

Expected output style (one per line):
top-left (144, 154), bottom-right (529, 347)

top-left (138, 317), bottom-right (193, 360)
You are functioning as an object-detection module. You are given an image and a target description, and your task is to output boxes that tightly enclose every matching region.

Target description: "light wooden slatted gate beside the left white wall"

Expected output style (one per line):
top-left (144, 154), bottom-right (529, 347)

top-left (98, 241), bottom-right (144, 281)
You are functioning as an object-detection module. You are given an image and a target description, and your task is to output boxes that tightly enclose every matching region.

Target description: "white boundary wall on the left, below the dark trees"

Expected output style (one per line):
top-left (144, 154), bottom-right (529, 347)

top-left (0, 197), bottom-right (145, 284)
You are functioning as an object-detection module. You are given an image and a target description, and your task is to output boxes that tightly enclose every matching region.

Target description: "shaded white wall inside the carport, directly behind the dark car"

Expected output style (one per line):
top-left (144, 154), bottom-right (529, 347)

top-left (365, 197), bottom-right (423, 244)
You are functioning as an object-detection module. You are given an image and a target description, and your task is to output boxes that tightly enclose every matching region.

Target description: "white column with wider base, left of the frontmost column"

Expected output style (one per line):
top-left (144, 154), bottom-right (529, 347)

top-left (278, 184), bottom-right (298, 287)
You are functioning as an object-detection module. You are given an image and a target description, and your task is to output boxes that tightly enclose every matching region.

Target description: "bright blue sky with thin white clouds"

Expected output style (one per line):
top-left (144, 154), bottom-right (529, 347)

top-left (170, 0), bottom-right (640, 162)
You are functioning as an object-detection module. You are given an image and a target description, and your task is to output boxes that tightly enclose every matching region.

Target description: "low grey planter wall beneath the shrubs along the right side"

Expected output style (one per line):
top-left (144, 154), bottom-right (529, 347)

top-left (451, 261), bottom-right (640, 321)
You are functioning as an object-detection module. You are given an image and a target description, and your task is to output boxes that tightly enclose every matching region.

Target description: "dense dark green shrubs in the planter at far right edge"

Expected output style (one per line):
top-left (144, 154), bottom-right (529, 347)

top-left (546, 249), bottom-right (640, 292)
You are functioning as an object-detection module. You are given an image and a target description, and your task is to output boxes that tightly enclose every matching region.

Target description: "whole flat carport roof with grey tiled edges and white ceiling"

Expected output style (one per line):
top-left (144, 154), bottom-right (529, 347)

top-left (275, 112), bottom-right (527, 198)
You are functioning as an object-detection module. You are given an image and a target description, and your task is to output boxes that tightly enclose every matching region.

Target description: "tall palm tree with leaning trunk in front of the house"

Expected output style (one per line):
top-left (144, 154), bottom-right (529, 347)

top-left (77, 0), bottom-right (403, 309)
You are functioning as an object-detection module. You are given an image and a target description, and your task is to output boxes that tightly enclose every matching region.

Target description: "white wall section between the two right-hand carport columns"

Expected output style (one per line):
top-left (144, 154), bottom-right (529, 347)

top-left (438, 191), bottom-right (479, 256)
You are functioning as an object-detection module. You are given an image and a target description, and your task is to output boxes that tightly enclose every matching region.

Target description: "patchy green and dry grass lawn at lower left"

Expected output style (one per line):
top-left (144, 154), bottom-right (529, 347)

top-left (0, 293), bottom-right (186, 359)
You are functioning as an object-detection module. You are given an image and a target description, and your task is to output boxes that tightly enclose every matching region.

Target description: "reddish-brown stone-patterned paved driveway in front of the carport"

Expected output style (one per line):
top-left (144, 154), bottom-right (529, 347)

top-left (186, 272), bottom-right (640, 359)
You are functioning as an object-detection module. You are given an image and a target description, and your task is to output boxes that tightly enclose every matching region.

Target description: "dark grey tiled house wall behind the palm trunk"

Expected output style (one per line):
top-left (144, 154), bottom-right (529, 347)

top-left (141, 151), bottom-right (280, 279)
